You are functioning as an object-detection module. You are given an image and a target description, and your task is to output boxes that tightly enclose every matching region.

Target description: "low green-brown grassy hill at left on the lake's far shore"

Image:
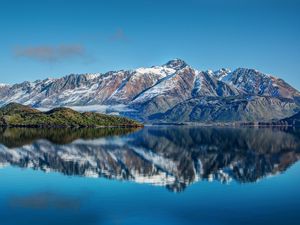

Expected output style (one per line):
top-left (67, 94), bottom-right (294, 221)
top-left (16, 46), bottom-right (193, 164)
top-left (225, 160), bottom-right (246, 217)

top-left (0, 103), bottom-right (142, 127)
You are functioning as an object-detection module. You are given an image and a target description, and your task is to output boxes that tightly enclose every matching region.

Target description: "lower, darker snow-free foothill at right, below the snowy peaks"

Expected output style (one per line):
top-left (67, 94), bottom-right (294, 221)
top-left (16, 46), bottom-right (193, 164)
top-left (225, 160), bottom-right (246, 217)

top-left (150, 96), bottom-right (297, 122)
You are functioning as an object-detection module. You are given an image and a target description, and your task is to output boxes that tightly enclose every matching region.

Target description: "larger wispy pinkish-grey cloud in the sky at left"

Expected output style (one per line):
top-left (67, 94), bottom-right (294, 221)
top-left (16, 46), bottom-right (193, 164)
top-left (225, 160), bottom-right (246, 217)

top-left (14, 45), bottom-right (87, 62)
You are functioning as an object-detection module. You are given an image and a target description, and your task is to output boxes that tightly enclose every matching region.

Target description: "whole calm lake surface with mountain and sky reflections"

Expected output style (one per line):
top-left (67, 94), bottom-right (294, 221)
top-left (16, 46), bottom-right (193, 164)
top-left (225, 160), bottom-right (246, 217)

top-left (0, 126), bottom-right (300, 225)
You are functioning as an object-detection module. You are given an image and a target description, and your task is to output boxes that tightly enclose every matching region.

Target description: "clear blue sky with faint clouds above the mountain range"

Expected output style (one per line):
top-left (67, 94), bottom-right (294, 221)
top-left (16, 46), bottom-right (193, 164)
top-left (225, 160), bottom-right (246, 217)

top-left (0, 0), bottom-right (300, 89)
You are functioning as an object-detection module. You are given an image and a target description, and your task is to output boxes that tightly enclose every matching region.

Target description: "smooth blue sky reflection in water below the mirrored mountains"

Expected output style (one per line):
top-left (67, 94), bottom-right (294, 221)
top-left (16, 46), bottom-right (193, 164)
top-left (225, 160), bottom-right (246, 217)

top-left (0, 164), bottom-right (300, 225)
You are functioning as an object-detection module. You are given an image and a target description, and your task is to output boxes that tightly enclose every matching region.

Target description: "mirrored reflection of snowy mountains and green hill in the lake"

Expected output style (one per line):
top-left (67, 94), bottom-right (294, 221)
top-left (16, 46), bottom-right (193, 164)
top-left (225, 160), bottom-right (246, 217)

top-left (0, 126), bottom-right (300, 191)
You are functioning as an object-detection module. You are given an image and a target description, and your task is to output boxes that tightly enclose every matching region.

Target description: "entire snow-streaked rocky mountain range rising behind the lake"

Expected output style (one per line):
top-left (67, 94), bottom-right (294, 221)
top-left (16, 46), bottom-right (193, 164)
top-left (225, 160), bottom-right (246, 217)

top-left (0, 59), bottom-right (300, 122)
